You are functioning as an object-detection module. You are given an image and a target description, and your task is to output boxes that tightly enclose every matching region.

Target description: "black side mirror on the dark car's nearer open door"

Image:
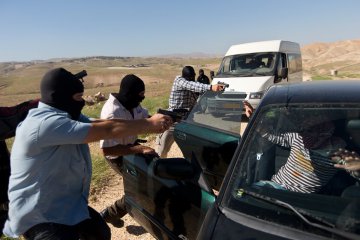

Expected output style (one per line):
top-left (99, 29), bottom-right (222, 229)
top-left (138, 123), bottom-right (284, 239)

top-left (154, 158), bottom-right (195, 180)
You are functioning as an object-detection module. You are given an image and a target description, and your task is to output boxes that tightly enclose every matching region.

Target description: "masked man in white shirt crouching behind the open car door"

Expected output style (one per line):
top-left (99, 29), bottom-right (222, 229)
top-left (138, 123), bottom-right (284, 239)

top-left (100, 74), bottom-right (157, 227)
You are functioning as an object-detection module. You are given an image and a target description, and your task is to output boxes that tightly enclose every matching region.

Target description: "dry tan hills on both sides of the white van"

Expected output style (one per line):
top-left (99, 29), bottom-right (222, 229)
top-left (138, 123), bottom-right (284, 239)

top-left (0, 40), bottom-right (360, 105)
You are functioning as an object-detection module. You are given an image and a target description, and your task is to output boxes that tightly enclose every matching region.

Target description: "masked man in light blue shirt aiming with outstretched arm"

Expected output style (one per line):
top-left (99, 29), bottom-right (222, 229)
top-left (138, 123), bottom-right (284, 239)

top-left (3, 68), bottom-right (172, 240)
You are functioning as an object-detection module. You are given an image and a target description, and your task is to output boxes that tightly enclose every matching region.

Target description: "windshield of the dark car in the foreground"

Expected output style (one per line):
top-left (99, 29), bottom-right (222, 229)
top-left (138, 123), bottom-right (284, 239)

top-left (223, 104), bottom-right (360, 237)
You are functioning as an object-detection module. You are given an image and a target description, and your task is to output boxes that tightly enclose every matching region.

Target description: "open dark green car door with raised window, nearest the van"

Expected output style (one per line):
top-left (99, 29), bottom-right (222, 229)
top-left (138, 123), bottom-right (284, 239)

top-left (174, 92), bottom-right (242, 190)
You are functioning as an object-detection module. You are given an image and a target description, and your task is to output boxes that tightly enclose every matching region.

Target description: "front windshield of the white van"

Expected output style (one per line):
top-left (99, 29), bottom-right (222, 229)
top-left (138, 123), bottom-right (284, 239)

top-left (217, 52), bottom-right (278, 77)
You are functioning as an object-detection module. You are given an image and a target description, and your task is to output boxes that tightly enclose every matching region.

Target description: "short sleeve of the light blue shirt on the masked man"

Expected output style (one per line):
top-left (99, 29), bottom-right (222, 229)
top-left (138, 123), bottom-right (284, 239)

top-left (37, 115), bottom-right (91, 147)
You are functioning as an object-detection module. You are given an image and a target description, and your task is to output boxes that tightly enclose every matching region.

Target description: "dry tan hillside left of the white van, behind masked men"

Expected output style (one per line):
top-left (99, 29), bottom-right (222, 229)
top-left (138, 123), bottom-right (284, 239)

top-left (0, 57), bottom-right (221, 106)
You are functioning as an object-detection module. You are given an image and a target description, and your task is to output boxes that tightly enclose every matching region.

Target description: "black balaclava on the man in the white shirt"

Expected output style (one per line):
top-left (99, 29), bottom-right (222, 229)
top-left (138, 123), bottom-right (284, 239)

top-left (117, 74), bottom-right (145, 112)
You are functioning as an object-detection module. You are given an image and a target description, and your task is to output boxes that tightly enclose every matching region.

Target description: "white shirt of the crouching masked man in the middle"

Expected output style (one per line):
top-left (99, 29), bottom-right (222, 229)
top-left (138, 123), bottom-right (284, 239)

top-left (100, 94), bottom-right (149, 158)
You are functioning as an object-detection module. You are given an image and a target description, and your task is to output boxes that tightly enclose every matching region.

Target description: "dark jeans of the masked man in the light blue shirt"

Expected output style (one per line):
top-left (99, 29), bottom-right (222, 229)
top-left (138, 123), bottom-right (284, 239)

top-left (23, 207), bottom-right (111, 240)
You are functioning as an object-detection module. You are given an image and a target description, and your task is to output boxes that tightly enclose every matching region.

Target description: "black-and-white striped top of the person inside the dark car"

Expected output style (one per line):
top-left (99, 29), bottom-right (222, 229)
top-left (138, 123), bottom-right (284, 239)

top-left (264, 133), bottom-right (345, 193)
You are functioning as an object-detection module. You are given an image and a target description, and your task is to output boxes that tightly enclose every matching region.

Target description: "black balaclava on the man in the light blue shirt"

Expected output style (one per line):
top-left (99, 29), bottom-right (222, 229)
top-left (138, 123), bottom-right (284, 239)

top-left (40, 68), bottom-right (85, 120)
